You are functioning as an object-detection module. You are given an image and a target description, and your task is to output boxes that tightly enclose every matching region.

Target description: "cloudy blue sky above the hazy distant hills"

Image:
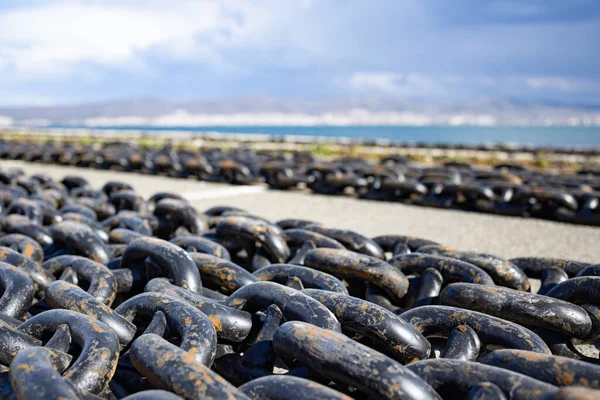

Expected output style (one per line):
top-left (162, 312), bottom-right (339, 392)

top-left (0, 0), bottom-right (600, 106)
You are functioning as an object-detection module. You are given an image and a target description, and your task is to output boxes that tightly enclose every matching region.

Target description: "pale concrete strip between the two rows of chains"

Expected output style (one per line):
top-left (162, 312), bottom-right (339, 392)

top-left (0, 161), bottom-right (600, 263)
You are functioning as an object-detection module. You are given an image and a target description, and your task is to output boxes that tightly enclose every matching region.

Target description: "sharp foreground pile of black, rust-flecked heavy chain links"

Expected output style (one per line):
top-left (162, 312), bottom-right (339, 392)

top-left (0, 170), bottom-right (600, 400)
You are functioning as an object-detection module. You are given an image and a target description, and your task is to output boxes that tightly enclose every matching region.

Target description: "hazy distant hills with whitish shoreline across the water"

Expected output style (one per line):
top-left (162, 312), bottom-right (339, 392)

top-left (0, 96), bottom-right (600, 126)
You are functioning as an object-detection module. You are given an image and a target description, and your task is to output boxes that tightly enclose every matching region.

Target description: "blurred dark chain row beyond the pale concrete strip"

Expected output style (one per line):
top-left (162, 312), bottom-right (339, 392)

top-left (0, 143), bottom-right (600, 226)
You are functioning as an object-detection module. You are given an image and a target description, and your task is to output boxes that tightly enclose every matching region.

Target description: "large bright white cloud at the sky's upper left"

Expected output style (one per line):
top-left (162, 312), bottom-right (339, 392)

top-left (0, 0), bottom-right (310, 79)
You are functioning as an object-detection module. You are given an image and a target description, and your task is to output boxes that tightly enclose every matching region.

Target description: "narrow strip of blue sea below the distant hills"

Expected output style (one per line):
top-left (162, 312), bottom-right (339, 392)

top-left (44, 125), bottom-right (600, 147)
